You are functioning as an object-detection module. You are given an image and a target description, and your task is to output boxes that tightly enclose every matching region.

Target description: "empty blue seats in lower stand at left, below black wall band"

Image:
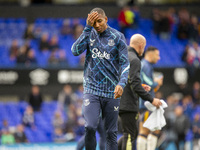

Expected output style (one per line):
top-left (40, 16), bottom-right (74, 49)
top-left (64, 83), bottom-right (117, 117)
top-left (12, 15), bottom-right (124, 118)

top-left (0, 101), bottom-right (59, 143)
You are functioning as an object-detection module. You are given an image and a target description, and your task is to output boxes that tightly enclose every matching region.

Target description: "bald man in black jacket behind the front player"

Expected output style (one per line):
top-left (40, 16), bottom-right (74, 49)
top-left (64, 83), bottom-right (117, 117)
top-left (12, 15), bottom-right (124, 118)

top-left (118, 34), bottom-right (161, 150)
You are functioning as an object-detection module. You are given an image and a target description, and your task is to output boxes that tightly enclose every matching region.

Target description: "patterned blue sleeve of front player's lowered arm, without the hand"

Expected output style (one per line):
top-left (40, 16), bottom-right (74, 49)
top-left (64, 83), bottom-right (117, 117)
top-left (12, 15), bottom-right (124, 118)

top-left (118, 35), bottom-right (130, 88)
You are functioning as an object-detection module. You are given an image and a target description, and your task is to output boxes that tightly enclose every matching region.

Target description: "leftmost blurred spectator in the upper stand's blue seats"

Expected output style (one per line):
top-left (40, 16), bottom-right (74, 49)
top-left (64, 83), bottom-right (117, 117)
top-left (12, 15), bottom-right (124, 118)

top-left (9, 39), bottom-right (19, 61)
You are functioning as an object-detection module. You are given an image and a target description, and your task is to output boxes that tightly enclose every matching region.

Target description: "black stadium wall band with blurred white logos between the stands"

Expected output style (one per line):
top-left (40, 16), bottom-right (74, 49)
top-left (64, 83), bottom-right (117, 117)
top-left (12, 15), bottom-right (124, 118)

top-left (0, 68), bottom-right (200, 100)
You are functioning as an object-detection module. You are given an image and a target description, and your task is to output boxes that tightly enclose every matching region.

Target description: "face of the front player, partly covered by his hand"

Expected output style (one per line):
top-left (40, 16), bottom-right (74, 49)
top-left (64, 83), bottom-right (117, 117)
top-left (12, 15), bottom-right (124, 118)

top-left (93, 14), bottom-right (108, 33)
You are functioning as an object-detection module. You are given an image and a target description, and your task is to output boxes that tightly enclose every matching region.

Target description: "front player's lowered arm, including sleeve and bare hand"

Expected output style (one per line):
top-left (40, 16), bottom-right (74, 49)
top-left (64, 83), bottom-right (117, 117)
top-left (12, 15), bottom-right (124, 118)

top-left (114, 35), bottom-right (130, 98)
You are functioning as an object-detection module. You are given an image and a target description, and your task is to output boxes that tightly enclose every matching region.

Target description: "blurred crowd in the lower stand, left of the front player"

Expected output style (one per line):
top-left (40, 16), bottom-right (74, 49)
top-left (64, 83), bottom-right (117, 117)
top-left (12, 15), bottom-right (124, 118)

top-left (0, 85), bottom-right (85, 144)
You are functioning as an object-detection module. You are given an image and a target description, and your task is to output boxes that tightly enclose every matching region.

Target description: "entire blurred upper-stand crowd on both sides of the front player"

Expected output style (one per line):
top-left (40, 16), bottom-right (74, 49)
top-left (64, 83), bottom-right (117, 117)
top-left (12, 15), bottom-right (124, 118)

top-left (4, 6), bottom-right (200, 67)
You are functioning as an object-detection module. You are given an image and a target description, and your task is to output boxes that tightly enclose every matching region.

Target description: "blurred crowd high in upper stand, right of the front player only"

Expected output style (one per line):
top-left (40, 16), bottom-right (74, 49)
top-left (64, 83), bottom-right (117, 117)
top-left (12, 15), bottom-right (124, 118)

top-left (118, 6), bottom-right (200, 42)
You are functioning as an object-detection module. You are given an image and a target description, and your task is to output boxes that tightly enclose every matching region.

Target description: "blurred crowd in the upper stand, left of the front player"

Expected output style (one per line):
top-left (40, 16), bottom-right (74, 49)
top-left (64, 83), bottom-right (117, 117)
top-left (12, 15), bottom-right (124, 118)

top-left (9, 19), bottom-right (83, 67)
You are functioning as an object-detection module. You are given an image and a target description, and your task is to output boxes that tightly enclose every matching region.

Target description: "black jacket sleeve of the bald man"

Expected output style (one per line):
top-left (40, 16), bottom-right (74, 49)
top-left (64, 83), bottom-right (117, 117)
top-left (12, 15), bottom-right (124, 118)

top-left (129, 60), bottom-right (153, 102)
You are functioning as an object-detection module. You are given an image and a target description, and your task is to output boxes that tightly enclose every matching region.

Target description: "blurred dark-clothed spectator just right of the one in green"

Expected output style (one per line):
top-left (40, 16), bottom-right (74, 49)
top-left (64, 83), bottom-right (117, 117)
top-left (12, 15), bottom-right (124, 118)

top-left (14, 124), bottom-right (28, 143)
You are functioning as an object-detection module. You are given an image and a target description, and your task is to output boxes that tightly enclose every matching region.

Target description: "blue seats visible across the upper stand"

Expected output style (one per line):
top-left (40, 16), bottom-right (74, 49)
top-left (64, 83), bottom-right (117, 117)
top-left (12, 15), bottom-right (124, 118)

top-left (0, 18), bottom-right (188, 67)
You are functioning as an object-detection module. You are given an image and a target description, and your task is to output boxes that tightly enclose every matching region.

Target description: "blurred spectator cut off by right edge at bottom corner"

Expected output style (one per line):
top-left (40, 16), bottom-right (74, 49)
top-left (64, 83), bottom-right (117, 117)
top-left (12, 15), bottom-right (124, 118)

top-left (192, 112), bottom-right (200, 150)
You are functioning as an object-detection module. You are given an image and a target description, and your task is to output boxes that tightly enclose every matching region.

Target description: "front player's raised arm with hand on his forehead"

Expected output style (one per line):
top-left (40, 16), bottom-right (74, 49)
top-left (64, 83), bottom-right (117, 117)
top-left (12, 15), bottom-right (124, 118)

top-left (71, 12), bottom-right (98, 56)
